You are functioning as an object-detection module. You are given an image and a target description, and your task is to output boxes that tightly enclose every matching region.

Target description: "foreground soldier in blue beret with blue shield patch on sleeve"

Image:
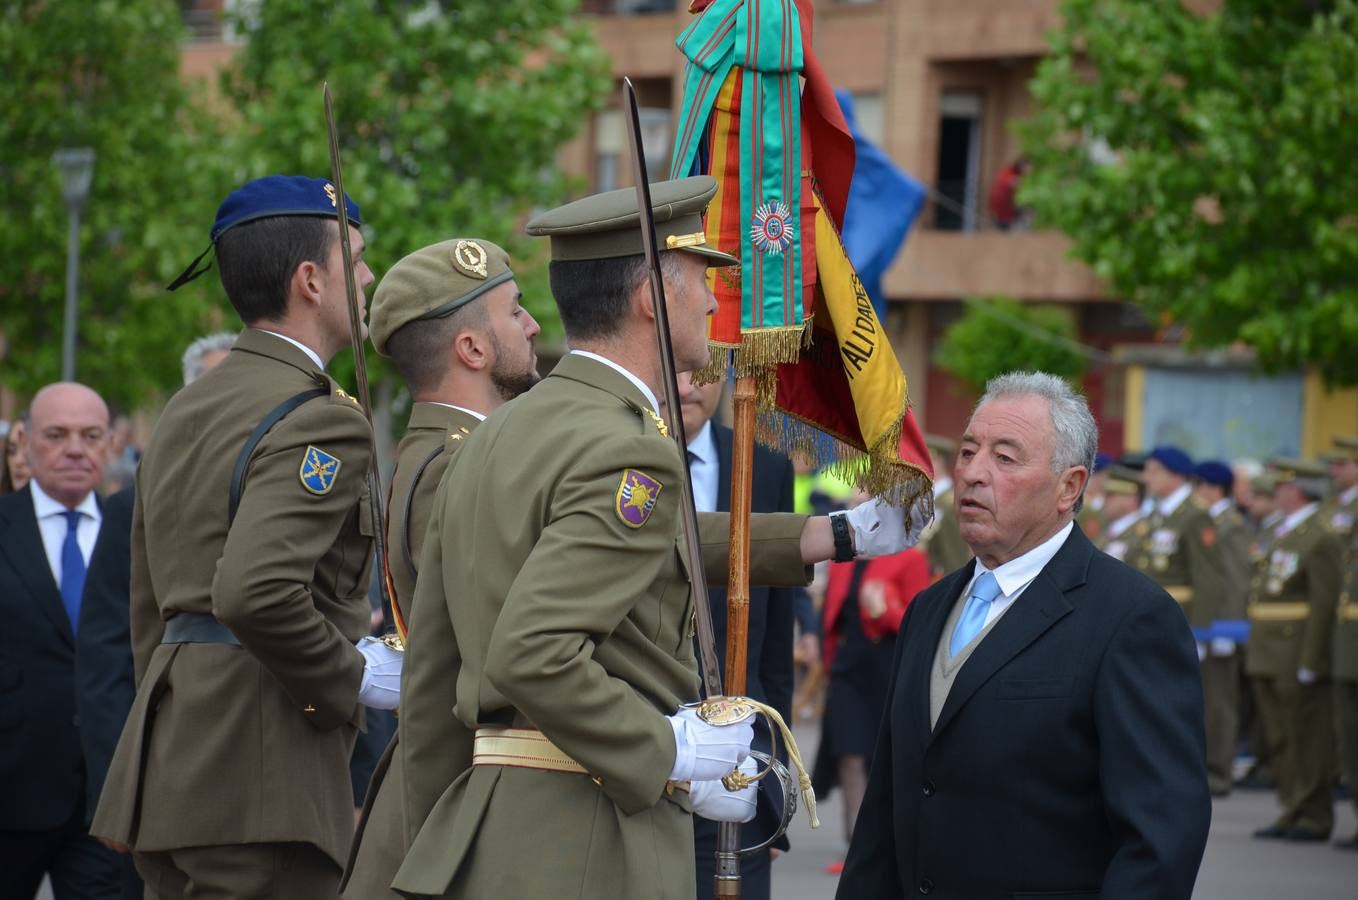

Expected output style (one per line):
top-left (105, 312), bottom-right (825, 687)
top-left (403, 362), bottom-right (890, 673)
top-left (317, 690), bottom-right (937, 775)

top-left (91, 176), bottom-right (401, 899)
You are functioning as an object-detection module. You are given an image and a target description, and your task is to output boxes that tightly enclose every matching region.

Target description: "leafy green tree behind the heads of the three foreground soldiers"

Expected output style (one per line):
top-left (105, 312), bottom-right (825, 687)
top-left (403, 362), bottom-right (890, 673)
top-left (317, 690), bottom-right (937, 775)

top-left (223, 0), bottom-right (610, 346)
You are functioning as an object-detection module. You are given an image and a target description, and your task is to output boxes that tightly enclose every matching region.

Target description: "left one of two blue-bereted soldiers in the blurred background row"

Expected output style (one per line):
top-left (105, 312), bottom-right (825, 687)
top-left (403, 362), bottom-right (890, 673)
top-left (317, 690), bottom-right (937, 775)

top-left (1127, 447), bottom-right (1221, 632)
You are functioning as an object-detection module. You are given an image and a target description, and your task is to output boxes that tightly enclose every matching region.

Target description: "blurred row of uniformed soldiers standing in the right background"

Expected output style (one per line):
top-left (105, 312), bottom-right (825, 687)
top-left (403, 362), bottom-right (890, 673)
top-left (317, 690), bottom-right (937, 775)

top-left (1042, 437), bottom-right (1358, 850)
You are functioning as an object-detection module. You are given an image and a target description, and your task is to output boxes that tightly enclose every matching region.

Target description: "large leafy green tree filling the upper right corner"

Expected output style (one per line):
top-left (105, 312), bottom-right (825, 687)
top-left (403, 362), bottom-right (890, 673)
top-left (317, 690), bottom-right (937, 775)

top-left (1020, 0), bottom-right (1358, 384)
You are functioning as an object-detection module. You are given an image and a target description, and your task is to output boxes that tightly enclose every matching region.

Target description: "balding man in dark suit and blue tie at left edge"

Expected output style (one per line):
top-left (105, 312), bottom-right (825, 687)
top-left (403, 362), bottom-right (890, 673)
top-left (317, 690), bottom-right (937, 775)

top-left (0, 384), bottom-right (120, 900)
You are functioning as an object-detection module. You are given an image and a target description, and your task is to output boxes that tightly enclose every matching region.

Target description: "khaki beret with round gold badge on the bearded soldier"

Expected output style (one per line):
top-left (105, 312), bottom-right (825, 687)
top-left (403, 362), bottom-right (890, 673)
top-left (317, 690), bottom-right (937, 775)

top-left (368, 238), bottom-right (513, 356)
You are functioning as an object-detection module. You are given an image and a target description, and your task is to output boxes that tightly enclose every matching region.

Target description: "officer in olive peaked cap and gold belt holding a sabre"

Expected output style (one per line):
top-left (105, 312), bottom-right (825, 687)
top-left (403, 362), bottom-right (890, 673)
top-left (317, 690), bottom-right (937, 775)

top-left (392, 176), bottom-right (922, 900)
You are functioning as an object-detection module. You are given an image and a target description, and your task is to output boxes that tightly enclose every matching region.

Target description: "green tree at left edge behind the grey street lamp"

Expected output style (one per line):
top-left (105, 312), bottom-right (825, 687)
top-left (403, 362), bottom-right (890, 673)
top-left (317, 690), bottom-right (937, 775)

top-left (0, 0), bottom-right (223, 407)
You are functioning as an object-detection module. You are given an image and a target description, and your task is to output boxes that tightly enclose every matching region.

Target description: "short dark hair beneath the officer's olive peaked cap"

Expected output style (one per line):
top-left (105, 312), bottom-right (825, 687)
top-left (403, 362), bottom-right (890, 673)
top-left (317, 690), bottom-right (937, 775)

top-left (547, 251), bottom-right (679, 341)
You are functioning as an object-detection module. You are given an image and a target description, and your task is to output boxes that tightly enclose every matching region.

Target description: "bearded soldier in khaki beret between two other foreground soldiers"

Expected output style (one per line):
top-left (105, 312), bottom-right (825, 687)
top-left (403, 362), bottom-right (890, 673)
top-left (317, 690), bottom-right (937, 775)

top-left (341, 238), bottom-right (539, 900)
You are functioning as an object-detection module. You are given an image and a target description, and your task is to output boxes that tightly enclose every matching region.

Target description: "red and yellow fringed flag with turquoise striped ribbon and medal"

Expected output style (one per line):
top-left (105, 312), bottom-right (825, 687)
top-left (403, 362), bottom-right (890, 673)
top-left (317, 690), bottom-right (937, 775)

top-left (669, 0), bottom-right (933, 504)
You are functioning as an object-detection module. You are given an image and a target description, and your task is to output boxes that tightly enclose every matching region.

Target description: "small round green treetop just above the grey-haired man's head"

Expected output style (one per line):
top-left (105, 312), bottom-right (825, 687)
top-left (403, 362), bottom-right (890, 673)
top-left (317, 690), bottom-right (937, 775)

top-left (934, 297), bottom-right (1088, 391)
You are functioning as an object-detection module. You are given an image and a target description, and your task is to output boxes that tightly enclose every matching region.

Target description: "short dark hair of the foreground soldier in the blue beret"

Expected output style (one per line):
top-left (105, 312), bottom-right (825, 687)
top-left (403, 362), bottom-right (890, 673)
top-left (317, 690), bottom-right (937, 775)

top-left (217, 216), bottom-right (340, 324)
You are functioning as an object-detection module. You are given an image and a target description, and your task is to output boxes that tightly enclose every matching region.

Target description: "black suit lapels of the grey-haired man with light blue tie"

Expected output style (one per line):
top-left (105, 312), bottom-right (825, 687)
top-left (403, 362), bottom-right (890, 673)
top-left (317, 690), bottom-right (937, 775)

top-left (925, 527), bottom-right (1093, 737)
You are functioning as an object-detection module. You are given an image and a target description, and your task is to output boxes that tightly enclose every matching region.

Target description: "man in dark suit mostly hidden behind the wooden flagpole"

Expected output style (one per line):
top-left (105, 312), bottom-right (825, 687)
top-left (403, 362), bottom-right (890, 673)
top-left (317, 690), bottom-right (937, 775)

top-left (679, 373), bottom-right (803, 900)
